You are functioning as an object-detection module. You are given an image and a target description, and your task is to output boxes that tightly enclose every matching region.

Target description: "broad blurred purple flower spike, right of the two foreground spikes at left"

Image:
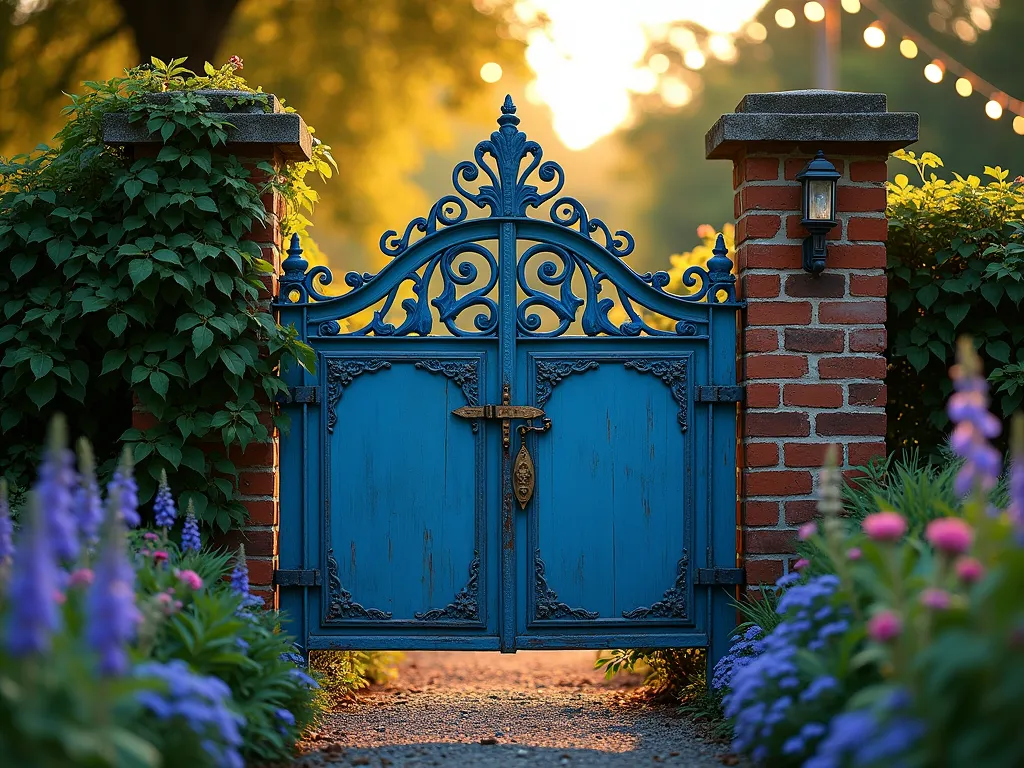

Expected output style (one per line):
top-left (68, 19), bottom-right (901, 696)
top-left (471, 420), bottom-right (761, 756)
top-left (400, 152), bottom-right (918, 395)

top-left (85, 490), bottom-right (140, 676)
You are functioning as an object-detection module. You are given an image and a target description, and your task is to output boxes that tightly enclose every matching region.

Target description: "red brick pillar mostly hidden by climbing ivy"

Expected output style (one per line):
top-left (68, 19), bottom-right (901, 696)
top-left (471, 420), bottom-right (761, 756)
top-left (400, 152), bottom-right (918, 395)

top-left (103, 91), bottom-right (312, 608)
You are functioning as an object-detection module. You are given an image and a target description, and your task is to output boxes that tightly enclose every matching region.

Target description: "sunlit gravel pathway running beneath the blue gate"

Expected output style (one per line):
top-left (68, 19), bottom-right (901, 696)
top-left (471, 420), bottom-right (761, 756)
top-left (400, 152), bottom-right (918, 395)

top-left (294, 651), bottom-right (735, 768)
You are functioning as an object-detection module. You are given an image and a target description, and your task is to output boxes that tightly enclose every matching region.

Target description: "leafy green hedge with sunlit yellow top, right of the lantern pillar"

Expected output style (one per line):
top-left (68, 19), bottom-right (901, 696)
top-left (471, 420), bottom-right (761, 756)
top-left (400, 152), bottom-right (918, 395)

top-left (886, 152), bottom-right (1024, 457)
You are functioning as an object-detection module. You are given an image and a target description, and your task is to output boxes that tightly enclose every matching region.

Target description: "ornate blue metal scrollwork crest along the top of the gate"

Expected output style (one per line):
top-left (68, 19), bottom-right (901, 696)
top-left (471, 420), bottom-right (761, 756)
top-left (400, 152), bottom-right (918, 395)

top-left (279, 96), bottom-right (738, 337)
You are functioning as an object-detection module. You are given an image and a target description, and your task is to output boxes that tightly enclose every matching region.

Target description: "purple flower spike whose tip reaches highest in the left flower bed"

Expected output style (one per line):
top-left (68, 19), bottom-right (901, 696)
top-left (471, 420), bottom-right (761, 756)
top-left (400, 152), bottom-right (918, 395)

top-left (35, 416), bottom-right (80, 562)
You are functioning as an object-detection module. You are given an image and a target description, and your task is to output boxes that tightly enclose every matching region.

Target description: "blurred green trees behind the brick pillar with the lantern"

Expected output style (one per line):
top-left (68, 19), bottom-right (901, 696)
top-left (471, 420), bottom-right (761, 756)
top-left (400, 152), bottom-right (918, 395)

top-left (624, 0), bottom-right (1024, 268)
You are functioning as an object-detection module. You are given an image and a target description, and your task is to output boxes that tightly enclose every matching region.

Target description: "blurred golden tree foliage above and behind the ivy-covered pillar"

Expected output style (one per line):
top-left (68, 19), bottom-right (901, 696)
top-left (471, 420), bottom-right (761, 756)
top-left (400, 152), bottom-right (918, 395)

top-left (0, 0), bottom-right (524, 256)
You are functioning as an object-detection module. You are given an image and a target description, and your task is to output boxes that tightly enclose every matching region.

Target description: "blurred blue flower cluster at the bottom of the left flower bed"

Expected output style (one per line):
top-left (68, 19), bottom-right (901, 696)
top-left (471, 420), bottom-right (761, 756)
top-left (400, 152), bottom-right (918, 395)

top-left (134, 659), bottom-right (246, 768)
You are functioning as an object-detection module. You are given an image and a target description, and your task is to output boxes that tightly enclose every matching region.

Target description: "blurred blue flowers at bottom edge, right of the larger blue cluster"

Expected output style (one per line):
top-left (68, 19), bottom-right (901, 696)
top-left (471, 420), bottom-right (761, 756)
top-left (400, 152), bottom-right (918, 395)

top-left (804, 692), bottom-right (925, 768)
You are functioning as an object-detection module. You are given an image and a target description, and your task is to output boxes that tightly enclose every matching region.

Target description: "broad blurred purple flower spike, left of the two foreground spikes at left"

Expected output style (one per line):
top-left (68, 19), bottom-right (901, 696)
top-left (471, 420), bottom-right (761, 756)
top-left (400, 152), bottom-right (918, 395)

top-left (6, 492), bottom-right (60, 656)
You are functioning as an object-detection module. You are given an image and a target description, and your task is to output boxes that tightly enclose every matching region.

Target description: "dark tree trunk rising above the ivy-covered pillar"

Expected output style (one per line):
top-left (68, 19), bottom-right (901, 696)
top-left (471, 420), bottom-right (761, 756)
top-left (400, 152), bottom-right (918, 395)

top-left (118, 0), bottom-right (239, 74)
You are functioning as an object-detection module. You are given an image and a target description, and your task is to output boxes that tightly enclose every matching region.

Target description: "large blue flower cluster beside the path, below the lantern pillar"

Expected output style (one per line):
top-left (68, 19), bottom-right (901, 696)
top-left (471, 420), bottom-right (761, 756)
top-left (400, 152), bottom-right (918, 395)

top-left (712, 574), bottom-right (849, 762)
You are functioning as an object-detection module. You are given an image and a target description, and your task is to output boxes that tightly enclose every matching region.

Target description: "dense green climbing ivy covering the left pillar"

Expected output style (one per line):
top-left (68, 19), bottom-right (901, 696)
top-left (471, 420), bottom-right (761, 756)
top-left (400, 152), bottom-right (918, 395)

top-left (0, 59), bottom-right (334, 529)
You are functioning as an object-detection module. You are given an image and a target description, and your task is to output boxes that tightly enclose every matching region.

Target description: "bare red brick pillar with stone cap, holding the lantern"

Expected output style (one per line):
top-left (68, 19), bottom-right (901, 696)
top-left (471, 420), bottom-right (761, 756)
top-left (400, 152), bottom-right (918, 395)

top-left (706, 91), bottom-right (918, 587)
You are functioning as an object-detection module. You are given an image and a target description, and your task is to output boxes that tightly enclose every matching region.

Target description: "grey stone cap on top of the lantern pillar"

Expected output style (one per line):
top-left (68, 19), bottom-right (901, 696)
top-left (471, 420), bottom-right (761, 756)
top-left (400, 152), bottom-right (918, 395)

top-left (705, 90), bottom-right (921, 159)
